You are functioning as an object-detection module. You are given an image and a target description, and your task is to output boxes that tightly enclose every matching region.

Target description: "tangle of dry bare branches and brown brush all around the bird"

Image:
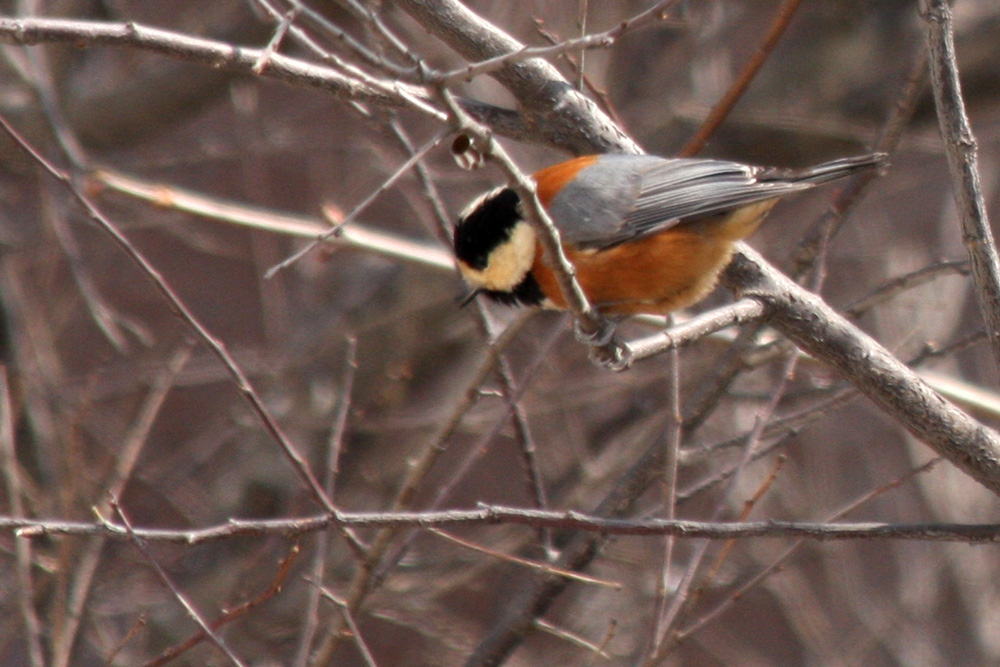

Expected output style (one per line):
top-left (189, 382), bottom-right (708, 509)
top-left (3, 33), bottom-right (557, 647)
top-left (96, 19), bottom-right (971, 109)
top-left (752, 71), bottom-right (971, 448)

top-left (0, 0), bottom-right (1000, 665)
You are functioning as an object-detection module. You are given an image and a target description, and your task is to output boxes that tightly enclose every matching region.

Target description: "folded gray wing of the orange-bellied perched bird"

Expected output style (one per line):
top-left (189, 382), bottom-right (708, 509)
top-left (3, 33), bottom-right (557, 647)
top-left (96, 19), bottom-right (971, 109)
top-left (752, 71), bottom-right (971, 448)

top-left (549, 155), bottom-right (814, 248)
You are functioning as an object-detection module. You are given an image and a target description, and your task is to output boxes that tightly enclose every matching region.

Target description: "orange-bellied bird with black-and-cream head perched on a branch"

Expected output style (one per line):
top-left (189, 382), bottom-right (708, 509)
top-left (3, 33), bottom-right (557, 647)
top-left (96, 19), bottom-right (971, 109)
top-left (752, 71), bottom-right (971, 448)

top-left (455, 154), bottom-right (885, 316)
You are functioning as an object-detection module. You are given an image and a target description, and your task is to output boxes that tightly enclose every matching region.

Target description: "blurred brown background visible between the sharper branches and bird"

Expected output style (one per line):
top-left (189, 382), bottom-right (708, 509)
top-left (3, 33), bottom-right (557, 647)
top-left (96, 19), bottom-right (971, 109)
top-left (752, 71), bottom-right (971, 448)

top-left (0, 0), bottom-right (1000, 665)
